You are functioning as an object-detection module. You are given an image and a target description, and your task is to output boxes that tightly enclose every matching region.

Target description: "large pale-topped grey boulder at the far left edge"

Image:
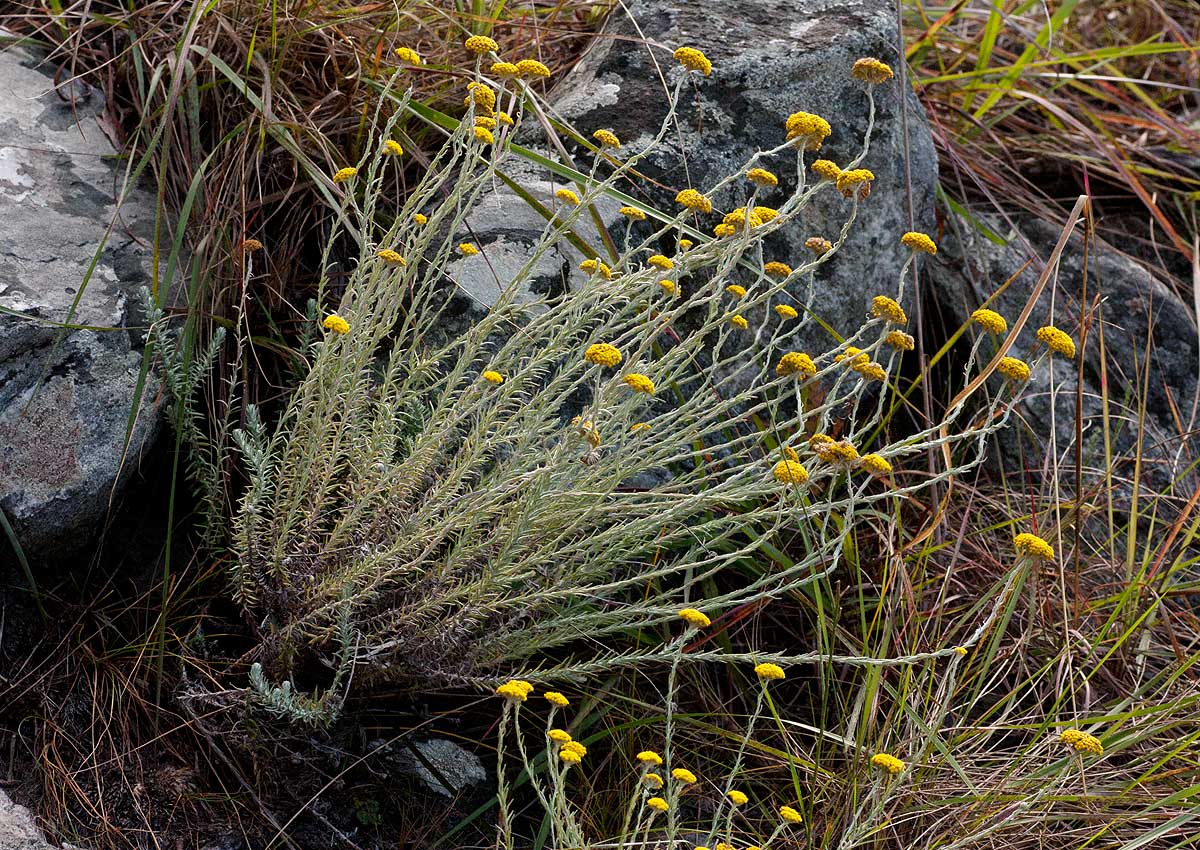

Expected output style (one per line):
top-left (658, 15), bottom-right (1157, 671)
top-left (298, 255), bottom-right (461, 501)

top-left (0, 41), bottom-right (157, 564)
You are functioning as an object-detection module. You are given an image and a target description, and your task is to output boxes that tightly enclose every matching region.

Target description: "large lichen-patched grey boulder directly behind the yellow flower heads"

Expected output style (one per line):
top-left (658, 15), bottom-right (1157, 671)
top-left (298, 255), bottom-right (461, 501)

top-left (451, 0), bottom-right (937, 349)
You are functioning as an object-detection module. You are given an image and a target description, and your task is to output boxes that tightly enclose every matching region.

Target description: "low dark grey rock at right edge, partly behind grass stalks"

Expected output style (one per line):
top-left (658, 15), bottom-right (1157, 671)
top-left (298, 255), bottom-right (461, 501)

top-left (925, 206), bottom-right (1200, 490)
